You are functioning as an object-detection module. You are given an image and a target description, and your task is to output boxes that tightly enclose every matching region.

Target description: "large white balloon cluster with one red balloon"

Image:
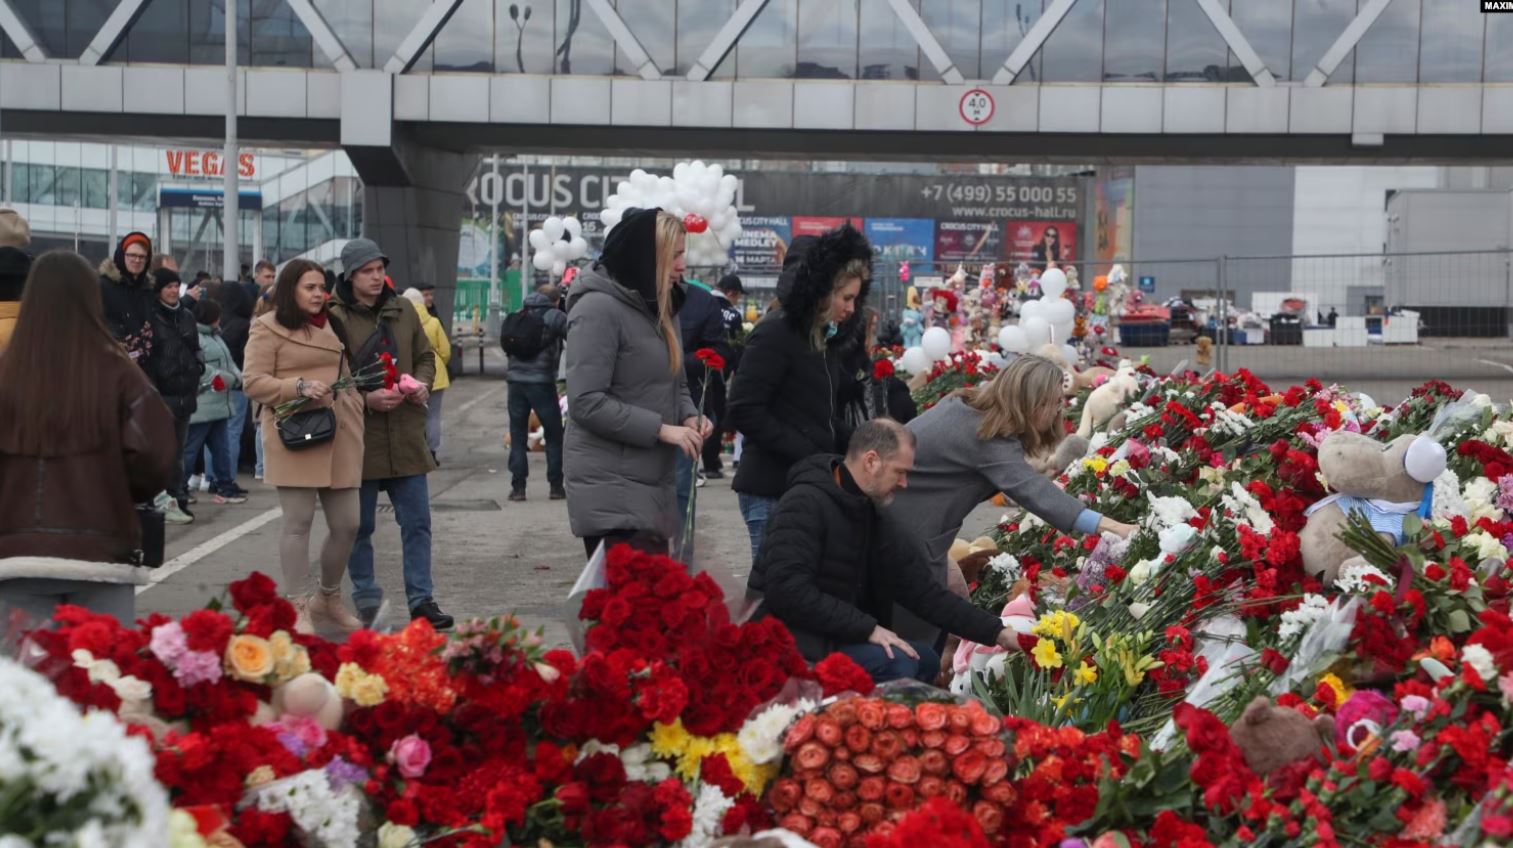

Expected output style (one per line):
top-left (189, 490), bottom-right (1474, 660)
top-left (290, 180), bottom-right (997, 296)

top-left (599, 162), bottom-right (741, 267)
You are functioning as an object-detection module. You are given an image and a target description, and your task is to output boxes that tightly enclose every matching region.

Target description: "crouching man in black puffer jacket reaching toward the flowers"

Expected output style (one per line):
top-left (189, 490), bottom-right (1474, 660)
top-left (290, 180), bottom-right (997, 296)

top-left (747, 418), bottom-right (1015, 683)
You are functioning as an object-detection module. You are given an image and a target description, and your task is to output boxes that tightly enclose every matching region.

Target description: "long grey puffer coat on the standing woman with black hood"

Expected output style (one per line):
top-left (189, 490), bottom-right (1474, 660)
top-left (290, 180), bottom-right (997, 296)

top-left (563, 265), bottom-right (699, 538)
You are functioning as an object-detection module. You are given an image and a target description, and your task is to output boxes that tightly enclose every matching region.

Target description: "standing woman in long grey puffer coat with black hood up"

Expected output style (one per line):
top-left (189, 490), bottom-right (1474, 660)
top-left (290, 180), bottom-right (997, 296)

top-left (563, 209), bottom-right (713, 556)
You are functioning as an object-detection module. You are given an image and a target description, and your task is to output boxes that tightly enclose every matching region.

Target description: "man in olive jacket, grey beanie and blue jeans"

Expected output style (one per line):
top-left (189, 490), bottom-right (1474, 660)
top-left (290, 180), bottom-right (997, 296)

top-left (330, 239), bottom-right (452, 630)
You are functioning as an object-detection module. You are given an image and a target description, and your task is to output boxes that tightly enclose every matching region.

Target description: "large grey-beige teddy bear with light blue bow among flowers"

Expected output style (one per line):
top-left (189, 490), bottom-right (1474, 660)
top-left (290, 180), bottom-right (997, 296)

top-left (1298, 430), bottom-right (1448, 586)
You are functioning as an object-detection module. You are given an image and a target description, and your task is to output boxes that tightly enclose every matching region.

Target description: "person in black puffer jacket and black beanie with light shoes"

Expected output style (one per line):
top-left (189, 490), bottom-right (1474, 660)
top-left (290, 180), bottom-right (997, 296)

top-left (139, 268), bottom-right (204, 524)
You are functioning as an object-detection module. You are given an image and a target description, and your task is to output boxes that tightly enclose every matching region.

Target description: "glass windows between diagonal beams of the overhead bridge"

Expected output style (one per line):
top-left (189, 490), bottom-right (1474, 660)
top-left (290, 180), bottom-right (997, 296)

top-left (0, 0), bottom-right (1513, 85)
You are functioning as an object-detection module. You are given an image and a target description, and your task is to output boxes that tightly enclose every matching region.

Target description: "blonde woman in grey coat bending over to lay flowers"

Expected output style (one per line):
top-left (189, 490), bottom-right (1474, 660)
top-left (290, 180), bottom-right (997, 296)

top-left (890, 356), bottom-right (1135, 641)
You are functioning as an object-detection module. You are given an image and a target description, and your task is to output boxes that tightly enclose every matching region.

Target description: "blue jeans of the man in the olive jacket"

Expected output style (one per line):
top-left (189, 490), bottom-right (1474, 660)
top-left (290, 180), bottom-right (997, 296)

top-left (346, 474), bottom-right (431, 610)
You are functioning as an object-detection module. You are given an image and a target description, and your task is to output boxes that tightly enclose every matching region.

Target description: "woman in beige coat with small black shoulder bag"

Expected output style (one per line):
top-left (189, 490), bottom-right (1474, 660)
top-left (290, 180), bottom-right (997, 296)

top-left (242, 259), bottom-right (363, 633)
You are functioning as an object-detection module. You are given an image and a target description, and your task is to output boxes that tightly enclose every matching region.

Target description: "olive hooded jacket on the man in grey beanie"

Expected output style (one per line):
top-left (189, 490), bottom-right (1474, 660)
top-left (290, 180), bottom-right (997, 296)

top-left (328, 269), bottom-right (436, 480)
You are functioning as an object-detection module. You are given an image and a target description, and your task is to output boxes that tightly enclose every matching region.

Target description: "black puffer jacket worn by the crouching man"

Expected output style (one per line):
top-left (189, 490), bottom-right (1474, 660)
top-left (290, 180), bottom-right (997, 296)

top-left (741, 456), bottom-right (1003, 662)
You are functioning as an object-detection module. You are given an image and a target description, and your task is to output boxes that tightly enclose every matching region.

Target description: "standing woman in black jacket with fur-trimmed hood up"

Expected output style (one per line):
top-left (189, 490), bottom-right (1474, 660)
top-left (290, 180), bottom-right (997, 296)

top-left (726, 224), bottom-right (871, 560)
